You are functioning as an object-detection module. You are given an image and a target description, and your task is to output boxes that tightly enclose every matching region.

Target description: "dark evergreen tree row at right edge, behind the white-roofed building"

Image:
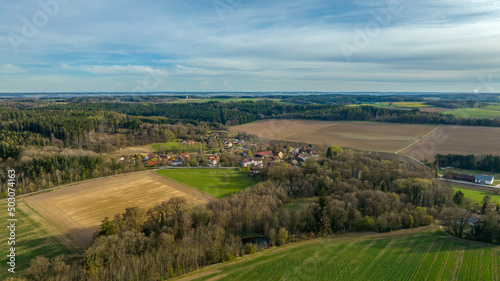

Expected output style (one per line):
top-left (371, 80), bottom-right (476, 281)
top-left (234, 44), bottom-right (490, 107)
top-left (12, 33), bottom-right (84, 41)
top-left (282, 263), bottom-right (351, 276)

top-left (435, 154), bottom-right (500, 173)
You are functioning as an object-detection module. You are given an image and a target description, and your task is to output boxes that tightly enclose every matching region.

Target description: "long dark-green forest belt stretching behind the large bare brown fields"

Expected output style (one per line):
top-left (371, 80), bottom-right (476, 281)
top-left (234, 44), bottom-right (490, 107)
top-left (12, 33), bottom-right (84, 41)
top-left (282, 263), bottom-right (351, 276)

top-left (37, 101), bottom-right (500, 126)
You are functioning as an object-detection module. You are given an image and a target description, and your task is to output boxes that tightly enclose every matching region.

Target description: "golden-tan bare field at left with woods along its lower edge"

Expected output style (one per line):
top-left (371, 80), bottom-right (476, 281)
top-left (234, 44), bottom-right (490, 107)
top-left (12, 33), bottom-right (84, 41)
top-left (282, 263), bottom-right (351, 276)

top-left (24, 172), bottom-right (214, 247)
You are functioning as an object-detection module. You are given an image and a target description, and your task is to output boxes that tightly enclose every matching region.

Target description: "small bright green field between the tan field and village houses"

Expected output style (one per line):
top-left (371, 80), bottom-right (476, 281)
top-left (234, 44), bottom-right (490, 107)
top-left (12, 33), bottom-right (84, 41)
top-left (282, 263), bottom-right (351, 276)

top-left (157, 169), bottom-right (258, 198)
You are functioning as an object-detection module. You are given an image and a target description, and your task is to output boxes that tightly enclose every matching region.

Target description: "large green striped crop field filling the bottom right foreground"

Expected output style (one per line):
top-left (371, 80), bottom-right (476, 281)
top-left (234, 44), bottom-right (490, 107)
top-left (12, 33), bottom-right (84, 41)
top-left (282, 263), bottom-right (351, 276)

top-left (178, 226), bottom-right (500, 281)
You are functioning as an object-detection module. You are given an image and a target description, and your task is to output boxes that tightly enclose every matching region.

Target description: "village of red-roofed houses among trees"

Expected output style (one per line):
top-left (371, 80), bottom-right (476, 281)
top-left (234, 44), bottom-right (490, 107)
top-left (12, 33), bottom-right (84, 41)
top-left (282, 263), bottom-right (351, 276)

top-left (116, 132), bottom-right (319, 176)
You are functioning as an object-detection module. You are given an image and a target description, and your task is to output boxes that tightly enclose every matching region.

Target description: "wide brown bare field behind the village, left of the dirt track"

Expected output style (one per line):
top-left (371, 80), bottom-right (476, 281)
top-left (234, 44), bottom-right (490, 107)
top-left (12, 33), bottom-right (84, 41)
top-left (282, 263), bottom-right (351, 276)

top-left (232, 120), bottom-right (436, 152)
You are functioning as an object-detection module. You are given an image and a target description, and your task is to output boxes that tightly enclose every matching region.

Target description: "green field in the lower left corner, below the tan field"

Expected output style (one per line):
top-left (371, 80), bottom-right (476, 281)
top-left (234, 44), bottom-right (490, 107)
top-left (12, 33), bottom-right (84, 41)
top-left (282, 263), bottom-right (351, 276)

top-left (0, 201), bottom-right (75, 280)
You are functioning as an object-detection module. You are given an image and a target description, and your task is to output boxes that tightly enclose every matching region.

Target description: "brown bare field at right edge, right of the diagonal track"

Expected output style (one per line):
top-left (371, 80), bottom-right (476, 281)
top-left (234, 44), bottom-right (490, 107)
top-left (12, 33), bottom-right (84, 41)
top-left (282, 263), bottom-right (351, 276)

top-left (398, 126), bottom-right (500, 161)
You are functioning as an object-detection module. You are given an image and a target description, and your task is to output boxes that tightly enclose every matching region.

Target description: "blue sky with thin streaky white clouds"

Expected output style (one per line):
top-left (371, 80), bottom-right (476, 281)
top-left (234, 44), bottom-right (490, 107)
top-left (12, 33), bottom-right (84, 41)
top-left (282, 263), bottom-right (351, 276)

top-left (0, 0), bottom-right (500, 93)
